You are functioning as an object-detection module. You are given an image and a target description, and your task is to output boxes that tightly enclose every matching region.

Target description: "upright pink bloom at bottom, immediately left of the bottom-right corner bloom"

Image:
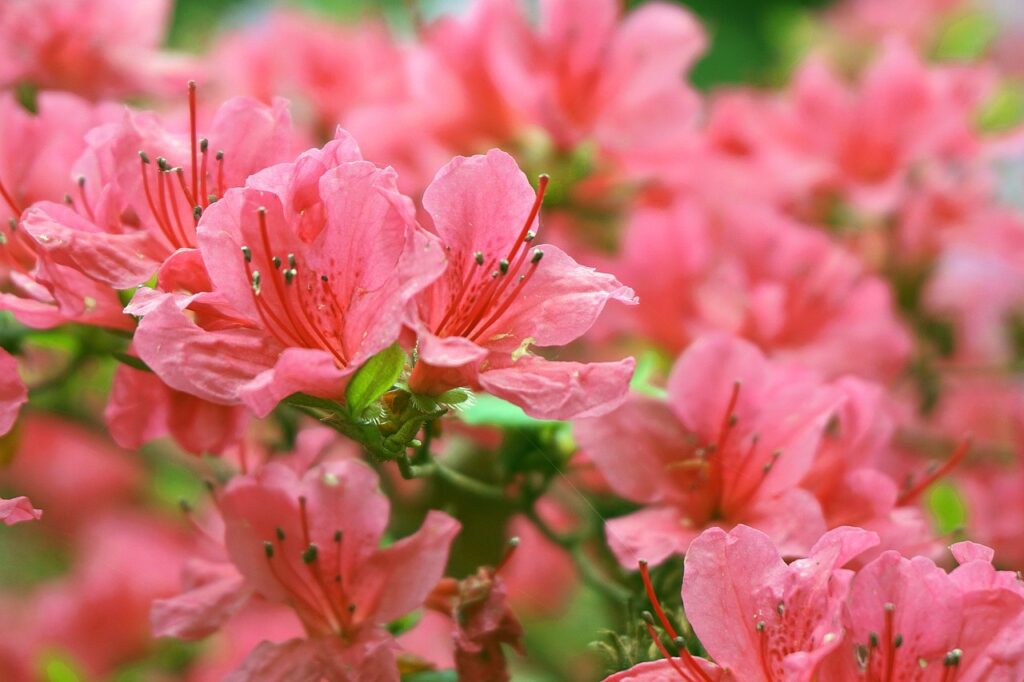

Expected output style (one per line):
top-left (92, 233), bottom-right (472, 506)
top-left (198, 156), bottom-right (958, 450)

top-left (683, 525), bottom-right (878, 682)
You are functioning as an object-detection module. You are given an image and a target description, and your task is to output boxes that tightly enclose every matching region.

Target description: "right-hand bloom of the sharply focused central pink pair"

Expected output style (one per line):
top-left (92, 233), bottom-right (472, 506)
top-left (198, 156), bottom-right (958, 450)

top-left (410, 150), bottom-right (635, 419)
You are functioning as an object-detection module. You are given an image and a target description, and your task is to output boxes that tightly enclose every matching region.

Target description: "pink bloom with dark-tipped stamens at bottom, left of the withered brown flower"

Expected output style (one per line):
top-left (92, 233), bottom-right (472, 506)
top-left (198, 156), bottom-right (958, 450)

top-left (153, 460), bottom-right (459, 681)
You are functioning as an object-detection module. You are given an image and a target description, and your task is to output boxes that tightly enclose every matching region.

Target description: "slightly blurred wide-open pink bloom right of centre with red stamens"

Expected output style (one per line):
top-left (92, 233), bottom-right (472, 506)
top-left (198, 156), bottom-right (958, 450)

top-left (575, 335), bottom-right (842, 566)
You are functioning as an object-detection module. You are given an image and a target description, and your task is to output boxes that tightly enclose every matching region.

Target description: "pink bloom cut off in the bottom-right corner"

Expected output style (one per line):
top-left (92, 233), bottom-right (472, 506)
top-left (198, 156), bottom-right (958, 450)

top-left (822, 543), bottom-right (1024, 682)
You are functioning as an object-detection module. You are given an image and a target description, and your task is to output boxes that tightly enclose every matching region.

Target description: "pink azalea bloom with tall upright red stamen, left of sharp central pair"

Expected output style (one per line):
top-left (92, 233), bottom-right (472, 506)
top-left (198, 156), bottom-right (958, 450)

top-left (24, 91), bottom-right (292, 289)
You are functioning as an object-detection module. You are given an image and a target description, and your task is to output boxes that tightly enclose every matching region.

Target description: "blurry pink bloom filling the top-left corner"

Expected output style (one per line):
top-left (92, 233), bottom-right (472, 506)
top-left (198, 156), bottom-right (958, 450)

top-left (0, 0), bottom-right (188, 98)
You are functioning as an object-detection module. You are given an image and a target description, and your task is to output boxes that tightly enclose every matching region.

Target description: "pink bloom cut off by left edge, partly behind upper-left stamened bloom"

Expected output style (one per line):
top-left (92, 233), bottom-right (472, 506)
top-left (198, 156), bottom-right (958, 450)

top-left (0, 92), bottom-right (130, 329)
